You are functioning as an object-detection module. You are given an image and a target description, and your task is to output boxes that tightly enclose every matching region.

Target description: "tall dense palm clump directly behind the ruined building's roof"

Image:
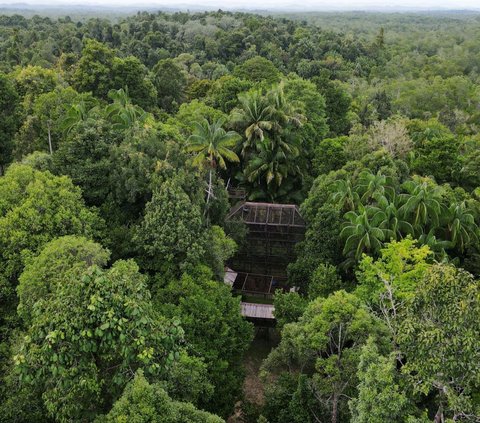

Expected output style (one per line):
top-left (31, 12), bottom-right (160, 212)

top-left (231, 83), bottom-right (305, 201)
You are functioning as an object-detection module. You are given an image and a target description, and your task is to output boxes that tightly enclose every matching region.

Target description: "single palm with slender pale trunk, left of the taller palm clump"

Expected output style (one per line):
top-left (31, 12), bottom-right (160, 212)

top-left (185, 119), bottom-right (240, 204)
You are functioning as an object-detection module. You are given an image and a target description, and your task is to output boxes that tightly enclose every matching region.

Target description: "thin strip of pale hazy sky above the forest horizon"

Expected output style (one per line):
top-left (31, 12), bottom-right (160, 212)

top-left (0, 0), bottom-right (480, 10)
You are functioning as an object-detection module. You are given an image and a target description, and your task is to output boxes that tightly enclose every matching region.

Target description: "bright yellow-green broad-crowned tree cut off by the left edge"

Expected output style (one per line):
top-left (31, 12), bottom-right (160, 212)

top-left (0, 164), bottom-right (100, 280)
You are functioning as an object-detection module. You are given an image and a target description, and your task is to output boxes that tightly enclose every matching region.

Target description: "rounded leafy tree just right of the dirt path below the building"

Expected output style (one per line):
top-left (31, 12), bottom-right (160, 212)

top-left (264, 291), bottom-right (385, 422)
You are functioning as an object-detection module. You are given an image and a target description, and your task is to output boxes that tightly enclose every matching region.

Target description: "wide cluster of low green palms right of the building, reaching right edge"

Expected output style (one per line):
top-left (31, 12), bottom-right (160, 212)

top-left (312, 163), bottom-right (479, 270)
